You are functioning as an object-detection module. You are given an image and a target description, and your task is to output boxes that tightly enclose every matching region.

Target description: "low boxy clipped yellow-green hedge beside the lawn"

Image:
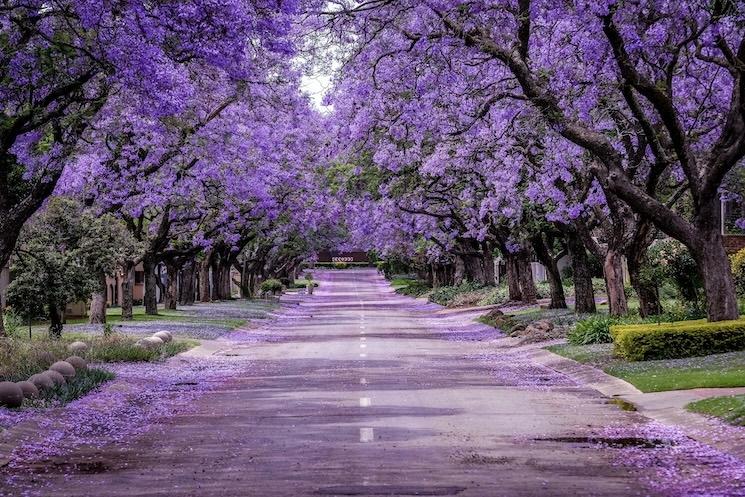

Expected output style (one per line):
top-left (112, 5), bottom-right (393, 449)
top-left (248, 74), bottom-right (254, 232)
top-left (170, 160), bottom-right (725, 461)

top-left (610, 319), bottom-right (745, 361)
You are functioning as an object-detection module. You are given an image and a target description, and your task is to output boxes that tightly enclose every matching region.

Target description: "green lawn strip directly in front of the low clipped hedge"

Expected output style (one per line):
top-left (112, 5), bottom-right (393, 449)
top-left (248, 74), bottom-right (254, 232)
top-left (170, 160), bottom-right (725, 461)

top-left (548, 344), bottom-right (745, 392)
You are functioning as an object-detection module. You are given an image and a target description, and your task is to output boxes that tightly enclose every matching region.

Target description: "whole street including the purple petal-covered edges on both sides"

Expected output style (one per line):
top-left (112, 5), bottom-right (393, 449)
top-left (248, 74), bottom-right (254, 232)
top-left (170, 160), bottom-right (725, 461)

top-left (0, 270), bottom-right (745, 496)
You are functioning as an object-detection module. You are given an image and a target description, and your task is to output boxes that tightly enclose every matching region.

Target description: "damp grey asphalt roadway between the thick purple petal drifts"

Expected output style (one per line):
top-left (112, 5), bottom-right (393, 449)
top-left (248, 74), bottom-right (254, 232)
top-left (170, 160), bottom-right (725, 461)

top-left (0, 270), bottom-right (728, 497)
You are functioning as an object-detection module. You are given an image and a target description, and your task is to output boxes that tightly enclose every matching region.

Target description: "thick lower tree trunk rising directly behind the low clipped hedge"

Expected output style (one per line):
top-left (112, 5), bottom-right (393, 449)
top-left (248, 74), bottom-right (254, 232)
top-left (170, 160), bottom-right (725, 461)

top-left (689, 226), bottom-right (740, 321)
